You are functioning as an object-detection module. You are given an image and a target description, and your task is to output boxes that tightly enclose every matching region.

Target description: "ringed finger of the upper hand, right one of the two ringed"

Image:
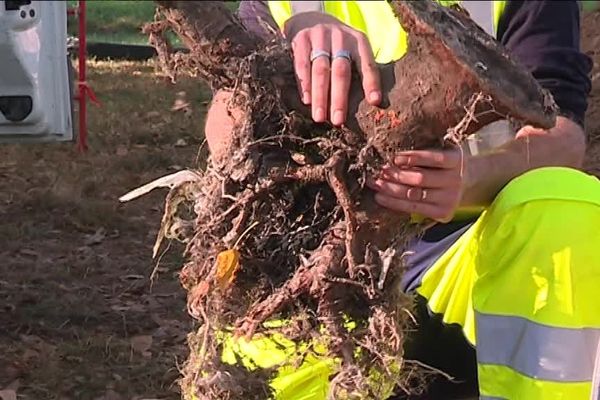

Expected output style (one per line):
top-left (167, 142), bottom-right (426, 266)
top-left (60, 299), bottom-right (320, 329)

top-left (330, 29), bottom-right (352, 126)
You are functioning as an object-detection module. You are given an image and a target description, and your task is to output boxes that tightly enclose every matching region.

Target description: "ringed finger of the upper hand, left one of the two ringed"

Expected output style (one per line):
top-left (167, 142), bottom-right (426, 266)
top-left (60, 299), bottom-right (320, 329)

top-left (310, 25), bottom-right (331, 122)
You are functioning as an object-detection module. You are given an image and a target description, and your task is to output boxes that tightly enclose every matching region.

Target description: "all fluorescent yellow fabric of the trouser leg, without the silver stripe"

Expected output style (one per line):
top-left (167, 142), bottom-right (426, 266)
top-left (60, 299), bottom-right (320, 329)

top-left (417, 167), bottom-right (600, 400)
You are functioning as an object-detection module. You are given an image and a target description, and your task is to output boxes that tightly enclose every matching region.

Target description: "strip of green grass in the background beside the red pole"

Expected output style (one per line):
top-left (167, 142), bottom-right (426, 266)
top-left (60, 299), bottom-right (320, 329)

top-left (69, 0), bottom-right (238, 44)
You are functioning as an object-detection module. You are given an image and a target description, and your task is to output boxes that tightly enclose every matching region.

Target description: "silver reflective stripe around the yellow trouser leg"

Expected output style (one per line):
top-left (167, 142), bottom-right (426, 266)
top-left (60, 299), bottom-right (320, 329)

top-left (475, 312), bottom-right (600, 382)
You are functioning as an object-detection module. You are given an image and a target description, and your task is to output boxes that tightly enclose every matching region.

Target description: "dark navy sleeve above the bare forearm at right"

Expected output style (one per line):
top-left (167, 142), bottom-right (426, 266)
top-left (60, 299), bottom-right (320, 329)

top-left (498, 0), bottom-right (592, 125)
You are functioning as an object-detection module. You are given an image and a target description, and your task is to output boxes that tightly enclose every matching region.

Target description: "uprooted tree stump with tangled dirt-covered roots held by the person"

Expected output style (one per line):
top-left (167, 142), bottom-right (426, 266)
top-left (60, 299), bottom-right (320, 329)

top-left (125, 1), bottom-right (555, 399)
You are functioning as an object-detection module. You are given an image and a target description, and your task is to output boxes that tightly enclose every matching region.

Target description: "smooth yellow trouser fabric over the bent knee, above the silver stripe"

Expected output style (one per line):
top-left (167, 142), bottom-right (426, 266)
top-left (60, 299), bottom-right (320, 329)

top-left (474, 169), bottom-right (600, 328)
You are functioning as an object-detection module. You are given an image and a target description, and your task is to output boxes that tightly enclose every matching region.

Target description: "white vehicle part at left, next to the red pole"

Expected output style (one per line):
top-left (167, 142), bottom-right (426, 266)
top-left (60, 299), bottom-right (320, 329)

top-left (0, 0), bottom-right (74, 143)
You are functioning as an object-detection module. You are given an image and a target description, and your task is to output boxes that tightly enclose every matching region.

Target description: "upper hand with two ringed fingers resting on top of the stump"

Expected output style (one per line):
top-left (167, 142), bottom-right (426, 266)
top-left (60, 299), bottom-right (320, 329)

top-left (284, 12), bottom-right (382, 126)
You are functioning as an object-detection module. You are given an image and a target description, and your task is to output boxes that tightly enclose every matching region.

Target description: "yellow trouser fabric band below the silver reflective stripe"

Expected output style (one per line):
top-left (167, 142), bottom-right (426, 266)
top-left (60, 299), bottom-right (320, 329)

top-left (477, 365), bottom-right (592, 400)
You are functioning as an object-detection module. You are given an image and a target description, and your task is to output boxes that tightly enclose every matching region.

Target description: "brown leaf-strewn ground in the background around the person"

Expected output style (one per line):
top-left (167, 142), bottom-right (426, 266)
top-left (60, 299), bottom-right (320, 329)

top-left (0, 7), bottom-right (600, 400)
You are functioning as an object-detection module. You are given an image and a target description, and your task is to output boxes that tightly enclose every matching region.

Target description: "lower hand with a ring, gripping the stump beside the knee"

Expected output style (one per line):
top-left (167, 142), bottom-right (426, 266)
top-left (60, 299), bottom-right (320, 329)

top-left (367, 149), bottom-right (466, 222)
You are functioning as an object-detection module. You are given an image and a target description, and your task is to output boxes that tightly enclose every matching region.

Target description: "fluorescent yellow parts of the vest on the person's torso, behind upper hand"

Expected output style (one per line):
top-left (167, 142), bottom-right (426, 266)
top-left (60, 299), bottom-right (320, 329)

top-left (267, 0), bottom-right (506, 64)
